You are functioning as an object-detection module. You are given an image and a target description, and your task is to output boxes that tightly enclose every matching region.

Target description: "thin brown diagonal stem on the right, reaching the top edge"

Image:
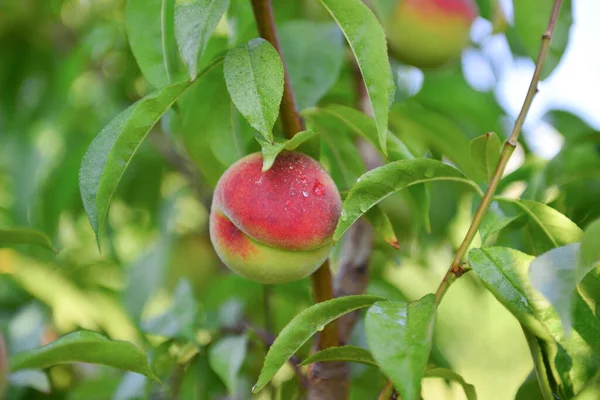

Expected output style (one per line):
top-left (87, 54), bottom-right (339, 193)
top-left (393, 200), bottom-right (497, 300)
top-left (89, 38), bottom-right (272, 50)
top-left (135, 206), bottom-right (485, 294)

top-left (435, 0), bottom-right (563, 304)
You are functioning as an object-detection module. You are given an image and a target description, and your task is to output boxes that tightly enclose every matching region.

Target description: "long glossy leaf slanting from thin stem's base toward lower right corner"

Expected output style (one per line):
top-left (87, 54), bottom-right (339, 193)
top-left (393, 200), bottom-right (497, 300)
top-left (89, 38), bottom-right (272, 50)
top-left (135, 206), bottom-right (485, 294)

top-left (469, 247), bottom-right (600, 396)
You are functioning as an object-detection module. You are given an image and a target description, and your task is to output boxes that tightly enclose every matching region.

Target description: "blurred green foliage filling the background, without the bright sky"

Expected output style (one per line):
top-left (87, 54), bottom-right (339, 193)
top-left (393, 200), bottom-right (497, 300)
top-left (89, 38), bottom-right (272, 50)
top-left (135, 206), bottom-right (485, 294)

top-left (0, 0), bottom-right (600, 400)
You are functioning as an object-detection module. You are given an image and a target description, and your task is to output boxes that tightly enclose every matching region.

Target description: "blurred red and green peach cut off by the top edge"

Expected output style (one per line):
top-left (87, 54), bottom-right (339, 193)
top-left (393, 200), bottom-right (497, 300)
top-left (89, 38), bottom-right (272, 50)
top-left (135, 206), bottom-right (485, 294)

top-left (381, 0), bottom-right (479, 68)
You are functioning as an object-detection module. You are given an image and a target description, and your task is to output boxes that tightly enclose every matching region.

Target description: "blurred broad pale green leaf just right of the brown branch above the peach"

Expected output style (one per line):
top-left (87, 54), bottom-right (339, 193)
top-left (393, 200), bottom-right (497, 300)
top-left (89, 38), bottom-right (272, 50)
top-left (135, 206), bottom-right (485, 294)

top-left (278, 21), bottom-right (344, 110)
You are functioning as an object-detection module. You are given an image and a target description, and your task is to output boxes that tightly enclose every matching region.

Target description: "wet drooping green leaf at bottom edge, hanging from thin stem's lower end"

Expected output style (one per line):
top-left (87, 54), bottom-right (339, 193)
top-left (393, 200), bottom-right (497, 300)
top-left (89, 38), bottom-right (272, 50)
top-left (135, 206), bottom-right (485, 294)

top-left (365, 294), bottom-right (436, 400)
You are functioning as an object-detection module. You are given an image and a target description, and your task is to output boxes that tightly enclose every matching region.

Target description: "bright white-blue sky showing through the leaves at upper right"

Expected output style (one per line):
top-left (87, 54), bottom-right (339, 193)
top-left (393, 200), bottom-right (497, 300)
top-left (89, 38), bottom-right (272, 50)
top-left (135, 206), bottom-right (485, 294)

top-left (463, 0), bottom-right (600, 159)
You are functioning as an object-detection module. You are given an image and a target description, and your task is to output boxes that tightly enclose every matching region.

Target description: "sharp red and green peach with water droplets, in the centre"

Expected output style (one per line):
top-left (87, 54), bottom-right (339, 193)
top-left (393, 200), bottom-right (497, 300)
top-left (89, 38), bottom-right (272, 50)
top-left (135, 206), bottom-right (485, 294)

top-left (210, 151), bottom-right (341, 283)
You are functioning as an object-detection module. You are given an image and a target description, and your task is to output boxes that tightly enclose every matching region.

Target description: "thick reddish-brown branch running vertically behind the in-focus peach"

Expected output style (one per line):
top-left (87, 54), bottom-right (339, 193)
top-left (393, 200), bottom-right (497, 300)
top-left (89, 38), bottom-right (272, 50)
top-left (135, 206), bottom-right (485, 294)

top-left (251, 0), bottom-right (339, 350)
